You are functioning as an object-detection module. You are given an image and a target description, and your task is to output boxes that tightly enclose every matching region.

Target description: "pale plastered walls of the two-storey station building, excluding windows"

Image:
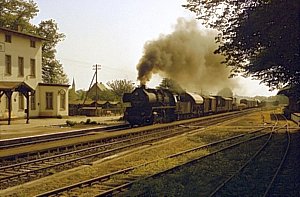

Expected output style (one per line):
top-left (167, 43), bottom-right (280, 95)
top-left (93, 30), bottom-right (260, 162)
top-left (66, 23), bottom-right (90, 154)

top-left (0, 30), bottom-right (69, 119)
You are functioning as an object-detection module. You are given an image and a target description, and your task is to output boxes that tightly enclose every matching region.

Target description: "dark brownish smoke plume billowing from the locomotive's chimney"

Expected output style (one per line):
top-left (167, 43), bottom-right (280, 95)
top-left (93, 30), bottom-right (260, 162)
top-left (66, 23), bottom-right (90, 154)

top-left (137, 18), bottom-right (236, 91)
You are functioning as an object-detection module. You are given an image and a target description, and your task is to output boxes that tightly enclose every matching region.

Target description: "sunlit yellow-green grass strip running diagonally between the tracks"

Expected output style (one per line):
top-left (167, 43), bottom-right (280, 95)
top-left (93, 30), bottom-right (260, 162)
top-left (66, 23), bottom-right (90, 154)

top-left (0, 108), bottom-right (290, 196)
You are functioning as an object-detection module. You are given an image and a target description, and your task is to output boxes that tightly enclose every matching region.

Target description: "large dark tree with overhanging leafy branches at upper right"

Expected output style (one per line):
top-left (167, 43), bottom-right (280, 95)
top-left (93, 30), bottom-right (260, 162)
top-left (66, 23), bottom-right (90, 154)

top-left (183, 0), bottom-right (300, 89)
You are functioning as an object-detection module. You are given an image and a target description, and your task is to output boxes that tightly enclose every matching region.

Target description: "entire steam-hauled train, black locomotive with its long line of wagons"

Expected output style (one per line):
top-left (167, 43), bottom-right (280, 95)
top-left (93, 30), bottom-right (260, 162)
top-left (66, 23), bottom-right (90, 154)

top-left (122, 86), bottom-right (258, 126)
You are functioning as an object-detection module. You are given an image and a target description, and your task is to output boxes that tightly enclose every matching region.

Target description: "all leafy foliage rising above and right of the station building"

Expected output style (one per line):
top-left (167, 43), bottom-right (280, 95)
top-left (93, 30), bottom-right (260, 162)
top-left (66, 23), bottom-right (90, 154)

top-left (0, 0), bottom-right (68, 83)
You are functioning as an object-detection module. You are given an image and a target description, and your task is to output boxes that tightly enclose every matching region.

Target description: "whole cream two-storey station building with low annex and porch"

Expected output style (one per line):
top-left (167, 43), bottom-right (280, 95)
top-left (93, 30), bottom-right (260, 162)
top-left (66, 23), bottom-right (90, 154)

top-left (0, 27), bottom-right (69, 123)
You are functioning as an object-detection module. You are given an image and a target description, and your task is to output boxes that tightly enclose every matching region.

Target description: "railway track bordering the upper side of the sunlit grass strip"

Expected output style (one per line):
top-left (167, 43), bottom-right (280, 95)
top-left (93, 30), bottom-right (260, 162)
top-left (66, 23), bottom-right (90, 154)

top-left (0, 109), bottom-right (255, 189)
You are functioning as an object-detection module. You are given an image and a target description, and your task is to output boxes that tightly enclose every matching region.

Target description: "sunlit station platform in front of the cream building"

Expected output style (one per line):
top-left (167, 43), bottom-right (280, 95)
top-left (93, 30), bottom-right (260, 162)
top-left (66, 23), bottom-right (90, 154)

top-left (0, 116), bottom-right (123, 140)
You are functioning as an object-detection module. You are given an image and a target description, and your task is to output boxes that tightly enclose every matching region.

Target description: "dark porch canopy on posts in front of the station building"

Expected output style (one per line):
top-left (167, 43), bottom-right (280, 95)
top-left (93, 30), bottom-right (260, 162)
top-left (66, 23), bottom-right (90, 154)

top-left (0, 81), bottom-right (34, 125)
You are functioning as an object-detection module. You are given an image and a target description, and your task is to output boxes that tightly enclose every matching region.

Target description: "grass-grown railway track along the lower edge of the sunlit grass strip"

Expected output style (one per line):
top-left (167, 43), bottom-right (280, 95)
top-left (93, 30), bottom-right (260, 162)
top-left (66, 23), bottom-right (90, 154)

top-left (37, 125), bottom-right (269, 196)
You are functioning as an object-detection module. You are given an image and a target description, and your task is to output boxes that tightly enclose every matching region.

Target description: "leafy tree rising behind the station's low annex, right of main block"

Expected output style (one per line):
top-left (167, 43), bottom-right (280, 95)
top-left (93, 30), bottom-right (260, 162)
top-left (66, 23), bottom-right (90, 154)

top-left (37, 19), bottom-right (69, 84)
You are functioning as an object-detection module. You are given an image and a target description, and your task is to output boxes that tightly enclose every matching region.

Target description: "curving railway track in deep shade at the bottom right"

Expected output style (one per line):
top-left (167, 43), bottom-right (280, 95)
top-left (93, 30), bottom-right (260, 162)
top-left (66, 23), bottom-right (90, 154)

top-left (210, 125), bottom-right (290, 196)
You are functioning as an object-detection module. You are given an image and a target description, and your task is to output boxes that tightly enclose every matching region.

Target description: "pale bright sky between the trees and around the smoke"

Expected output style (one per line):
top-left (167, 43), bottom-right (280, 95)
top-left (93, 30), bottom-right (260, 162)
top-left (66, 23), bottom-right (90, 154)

top-left (31, 0), bottom-right (277, 96)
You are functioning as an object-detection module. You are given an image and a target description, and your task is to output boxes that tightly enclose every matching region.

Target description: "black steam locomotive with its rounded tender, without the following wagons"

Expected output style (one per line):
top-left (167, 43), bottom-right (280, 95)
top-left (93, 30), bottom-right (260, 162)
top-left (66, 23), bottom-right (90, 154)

top-left (123, 86), bottom-right (205, 125)
